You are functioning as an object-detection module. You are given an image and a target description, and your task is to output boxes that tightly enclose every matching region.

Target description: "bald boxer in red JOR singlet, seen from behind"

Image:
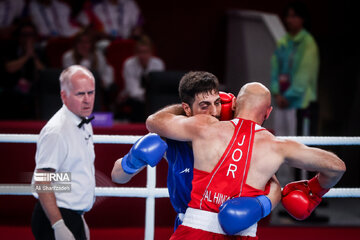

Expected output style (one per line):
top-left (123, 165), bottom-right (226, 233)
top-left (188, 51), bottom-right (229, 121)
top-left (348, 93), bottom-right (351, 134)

top-left (146, 83), bottom-right (345, 239)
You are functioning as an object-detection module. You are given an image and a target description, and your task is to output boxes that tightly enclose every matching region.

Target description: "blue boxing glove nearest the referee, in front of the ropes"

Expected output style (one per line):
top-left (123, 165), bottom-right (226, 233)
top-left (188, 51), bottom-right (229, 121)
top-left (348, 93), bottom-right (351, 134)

top-left (121, 133), bottom-right (167, 174)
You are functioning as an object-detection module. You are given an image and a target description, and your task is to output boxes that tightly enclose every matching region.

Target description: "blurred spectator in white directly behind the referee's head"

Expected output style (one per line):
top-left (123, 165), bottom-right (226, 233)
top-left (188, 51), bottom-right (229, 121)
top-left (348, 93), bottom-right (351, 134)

top-left (62, 30), bottom-right (116, 109)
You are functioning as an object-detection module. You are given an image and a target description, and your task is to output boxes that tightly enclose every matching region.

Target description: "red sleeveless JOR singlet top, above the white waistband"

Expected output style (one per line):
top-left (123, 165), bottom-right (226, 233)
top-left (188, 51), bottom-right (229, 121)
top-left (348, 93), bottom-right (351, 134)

top-left (189, 118), bottom-right (270, 212)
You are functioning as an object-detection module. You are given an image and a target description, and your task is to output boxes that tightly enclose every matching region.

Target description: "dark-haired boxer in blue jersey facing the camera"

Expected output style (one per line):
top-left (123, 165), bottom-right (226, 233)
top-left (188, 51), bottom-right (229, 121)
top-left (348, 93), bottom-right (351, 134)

top-left (111, 72), bottom-right (281, 229)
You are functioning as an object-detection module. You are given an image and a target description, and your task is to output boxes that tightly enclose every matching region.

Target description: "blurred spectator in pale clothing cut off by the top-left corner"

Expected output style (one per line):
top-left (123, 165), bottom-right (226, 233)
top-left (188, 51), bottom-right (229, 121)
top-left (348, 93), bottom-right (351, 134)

top-left (0, 0), bottom-right (25, 39)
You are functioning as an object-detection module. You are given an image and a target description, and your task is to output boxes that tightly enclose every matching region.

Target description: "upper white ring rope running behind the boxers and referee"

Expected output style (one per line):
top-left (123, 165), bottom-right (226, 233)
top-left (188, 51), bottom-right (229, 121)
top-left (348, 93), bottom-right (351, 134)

top-left (0, 133), bottom-right (360, 146)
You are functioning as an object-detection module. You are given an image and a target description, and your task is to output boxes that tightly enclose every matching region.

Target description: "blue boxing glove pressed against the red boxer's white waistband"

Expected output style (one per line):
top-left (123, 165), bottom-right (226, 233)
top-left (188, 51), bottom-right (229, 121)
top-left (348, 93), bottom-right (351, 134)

top-left (218, 195), bottom-right (271, 235)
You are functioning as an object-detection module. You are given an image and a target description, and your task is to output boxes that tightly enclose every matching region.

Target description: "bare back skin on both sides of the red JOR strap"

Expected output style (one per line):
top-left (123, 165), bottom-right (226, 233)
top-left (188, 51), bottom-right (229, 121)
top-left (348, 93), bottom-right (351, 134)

top-left (193, 115), bottom-right (283, 193)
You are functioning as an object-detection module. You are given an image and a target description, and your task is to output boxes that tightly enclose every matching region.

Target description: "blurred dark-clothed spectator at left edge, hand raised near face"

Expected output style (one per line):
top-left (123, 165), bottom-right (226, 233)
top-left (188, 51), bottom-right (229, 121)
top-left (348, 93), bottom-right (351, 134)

top-left (1, 22), bottom-right (44, 119)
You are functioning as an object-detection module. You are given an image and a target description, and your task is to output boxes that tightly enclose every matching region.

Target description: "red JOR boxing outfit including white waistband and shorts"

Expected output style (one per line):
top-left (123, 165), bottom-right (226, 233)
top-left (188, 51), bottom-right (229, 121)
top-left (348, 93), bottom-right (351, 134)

top-left (170, 118), bottom-right (270, 240)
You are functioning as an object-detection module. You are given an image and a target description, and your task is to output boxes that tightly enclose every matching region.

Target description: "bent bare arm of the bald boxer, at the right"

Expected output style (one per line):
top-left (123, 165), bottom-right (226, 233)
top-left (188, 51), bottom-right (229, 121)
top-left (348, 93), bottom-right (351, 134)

top-left (281, 140), bottom-right (346, 188)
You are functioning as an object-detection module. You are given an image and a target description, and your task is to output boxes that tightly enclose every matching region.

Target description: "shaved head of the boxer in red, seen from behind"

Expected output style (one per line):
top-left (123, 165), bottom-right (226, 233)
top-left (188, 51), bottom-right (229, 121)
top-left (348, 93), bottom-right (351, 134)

top-left (235, 82), bottom-right (272, 124)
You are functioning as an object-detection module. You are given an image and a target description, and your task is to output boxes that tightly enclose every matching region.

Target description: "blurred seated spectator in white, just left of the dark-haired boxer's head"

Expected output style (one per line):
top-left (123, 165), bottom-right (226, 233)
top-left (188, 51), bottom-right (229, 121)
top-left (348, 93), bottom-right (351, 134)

top-left (119, 35), bottom-right (165, 122)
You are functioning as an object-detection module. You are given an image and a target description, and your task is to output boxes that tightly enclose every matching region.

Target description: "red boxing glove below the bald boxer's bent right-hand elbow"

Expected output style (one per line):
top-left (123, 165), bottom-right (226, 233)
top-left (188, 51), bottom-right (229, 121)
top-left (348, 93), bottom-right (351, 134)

top-left (281, 175), bottom-right (329, 220)
